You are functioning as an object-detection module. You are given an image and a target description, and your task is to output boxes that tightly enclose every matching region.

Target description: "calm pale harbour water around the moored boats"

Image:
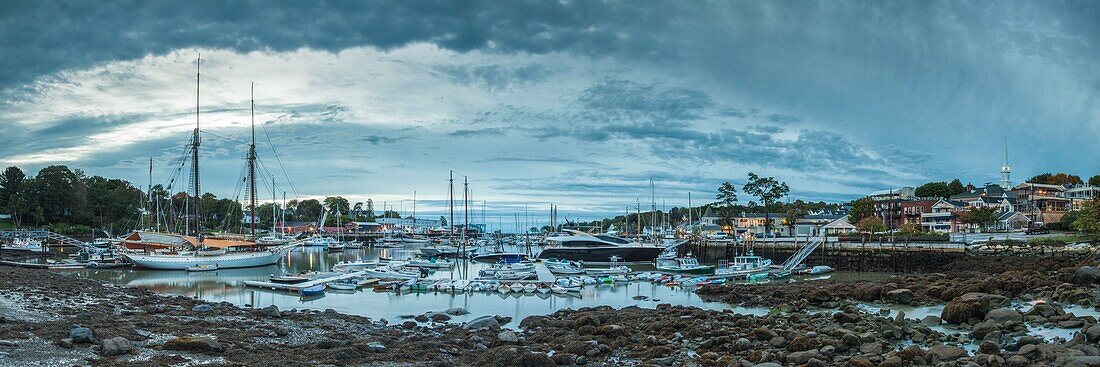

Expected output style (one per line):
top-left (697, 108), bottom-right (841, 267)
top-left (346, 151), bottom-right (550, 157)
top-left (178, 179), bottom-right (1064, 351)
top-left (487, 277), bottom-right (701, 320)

top-left (68, 247), bottom-right (768, 324)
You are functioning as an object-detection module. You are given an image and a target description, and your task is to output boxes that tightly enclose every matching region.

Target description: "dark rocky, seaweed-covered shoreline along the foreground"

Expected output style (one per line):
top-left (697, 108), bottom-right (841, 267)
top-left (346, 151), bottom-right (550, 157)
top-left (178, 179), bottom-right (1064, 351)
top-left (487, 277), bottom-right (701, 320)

top-left (0, 254), bottom-right (1100, 367)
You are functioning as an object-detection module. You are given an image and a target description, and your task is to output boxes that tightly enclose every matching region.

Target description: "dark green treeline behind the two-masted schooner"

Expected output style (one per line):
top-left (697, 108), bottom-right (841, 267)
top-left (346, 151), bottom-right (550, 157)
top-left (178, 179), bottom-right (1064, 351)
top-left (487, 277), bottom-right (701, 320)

top-left (0, 165), bottom-right (409, 234)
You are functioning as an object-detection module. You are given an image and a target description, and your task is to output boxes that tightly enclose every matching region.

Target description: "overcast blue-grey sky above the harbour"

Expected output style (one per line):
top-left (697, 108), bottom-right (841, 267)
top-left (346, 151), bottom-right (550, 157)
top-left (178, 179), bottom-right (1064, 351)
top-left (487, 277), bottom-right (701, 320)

top-left (0, 0), bottom-right (1100, 226)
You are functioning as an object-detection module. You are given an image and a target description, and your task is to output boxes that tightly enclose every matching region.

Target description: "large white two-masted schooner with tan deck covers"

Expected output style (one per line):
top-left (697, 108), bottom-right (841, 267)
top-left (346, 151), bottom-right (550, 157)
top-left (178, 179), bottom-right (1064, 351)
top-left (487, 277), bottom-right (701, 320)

top-left (121, 58), bottom-right (295, 270)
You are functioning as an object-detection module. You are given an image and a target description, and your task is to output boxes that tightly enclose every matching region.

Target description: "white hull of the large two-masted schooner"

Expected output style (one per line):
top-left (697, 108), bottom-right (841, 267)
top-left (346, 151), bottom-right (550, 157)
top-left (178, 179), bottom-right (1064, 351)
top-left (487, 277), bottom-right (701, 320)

top-left (123, 251), bottom-right (283, 270)
